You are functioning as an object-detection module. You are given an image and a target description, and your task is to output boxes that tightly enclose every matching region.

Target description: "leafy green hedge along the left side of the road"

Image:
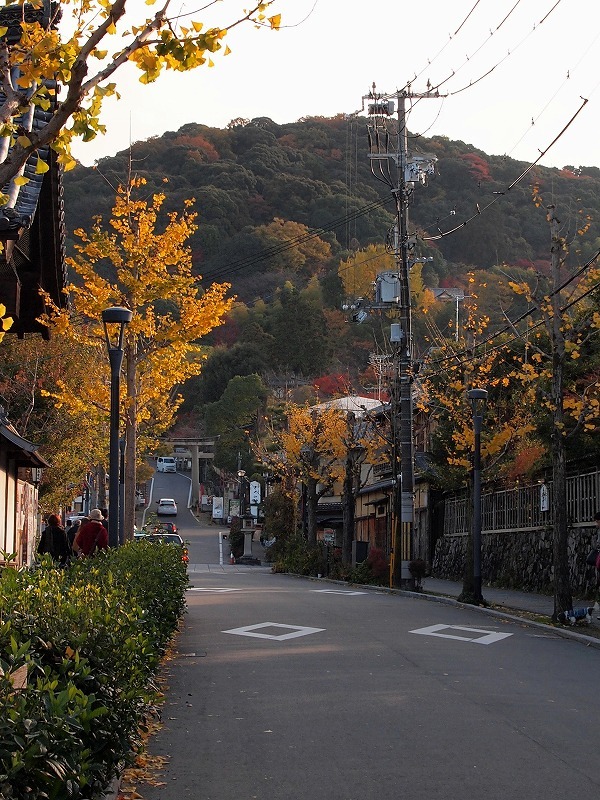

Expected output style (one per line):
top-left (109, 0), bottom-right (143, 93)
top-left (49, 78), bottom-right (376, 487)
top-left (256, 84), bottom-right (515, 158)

top-left (0, 542), bottom-right (188, 800)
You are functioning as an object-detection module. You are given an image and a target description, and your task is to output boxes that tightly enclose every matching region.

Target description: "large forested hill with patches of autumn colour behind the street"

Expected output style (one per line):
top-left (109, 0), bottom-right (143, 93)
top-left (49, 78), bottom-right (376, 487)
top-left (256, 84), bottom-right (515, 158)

top-left (65, 116), bottom-right (600, 399)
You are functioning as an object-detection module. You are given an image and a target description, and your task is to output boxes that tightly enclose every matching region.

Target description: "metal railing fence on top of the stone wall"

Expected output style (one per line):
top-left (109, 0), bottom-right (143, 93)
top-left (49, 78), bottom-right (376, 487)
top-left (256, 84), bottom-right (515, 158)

top-left (444, 468), bottom-right (600, 535)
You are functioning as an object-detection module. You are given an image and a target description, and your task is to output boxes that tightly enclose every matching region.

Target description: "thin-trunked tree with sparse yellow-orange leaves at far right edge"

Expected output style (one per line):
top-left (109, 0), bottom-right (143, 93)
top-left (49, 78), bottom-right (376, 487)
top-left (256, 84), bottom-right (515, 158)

top-left (511, 200), bottom-right (600, 620)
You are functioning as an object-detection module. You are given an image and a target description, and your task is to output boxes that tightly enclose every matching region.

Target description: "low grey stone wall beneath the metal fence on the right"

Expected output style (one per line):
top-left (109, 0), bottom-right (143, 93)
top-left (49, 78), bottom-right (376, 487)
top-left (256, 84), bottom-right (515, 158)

top-left (432, 526), bottom-right (596, 597)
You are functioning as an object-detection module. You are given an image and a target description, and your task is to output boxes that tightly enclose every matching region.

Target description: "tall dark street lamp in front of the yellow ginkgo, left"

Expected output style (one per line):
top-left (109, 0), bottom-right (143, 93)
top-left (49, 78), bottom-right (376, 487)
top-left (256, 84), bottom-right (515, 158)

top-left (102, 306), bottom-right (132, 547)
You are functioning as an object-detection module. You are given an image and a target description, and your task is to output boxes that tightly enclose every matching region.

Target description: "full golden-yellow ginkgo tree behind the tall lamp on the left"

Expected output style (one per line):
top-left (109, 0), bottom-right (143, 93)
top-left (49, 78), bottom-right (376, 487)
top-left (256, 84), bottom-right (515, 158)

top-left (42, 179), bottom-right (232, 532)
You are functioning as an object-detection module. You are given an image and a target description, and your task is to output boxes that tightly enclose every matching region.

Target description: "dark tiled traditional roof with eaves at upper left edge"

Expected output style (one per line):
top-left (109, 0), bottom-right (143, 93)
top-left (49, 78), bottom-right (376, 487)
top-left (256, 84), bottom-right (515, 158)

top-left (0, 0), bottom-right (67, 338)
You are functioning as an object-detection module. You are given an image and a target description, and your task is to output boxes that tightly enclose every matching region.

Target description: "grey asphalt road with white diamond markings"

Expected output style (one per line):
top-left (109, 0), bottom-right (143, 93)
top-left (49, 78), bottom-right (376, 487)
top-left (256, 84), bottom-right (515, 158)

top-left (139, 476), bottom-right (600, 800)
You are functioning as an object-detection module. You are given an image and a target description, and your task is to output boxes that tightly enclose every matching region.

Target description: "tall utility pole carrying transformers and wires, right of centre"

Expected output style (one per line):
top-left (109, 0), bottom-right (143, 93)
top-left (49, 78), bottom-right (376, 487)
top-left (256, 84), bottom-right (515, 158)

top-left (363, 84), bottom-right (440, 587)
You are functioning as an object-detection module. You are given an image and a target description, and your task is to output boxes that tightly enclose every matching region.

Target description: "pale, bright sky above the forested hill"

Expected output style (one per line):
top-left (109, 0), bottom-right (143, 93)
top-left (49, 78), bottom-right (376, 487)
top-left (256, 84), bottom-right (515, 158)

top-left (74, 0), bottom-right (600, 167)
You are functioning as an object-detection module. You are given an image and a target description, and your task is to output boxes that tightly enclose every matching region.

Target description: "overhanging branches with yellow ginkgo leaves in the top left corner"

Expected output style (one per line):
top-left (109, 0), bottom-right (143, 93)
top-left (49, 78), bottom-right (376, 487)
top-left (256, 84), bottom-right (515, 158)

top-left (0, 0), bottom-right (280, 186)
